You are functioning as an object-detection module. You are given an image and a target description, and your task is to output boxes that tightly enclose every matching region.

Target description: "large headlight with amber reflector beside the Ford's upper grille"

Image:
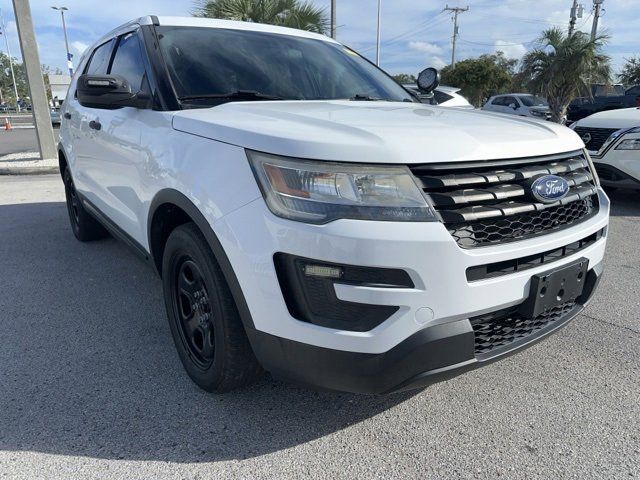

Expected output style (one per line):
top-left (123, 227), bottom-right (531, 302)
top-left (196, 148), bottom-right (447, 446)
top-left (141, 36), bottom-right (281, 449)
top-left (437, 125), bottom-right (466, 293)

top-left (247, 151), bottom-right (436, 223)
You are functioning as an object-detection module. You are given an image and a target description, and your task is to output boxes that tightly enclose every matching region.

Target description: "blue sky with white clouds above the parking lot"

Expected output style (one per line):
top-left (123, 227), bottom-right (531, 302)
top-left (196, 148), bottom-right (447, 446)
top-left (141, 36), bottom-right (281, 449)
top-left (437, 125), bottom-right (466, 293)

top-left (0, 0), bottom-right (640, 79)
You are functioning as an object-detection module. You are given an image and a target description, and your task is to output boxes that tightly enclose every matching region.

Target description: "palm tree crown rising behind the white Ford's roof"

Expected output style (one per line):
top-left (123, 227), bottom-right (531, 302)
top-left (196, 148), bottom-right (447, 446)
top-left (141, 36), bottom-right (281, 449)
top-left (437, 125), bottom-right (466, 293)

top-left (193, 0), bottom-right (329, 33)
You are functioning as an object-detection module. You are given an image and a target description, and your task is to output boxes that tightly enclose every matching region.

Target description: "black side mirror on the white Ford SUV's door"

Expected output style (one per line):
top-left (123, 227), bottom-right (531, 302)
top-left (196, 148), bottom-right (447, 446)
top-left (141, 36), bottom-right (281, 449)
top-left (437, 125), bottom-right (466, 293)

top-left (76, 74), bottom-right (150, 109)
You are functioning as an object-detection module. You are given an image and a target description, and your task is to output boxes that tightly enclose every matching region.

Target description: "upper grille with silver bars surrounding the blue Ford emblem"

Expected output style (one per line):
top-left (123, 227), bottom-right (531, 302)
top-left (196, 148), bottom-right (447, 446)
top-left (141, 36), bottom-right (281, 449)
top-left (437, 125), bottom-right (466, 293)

top-left (411, 152), bottom-right (598, 248)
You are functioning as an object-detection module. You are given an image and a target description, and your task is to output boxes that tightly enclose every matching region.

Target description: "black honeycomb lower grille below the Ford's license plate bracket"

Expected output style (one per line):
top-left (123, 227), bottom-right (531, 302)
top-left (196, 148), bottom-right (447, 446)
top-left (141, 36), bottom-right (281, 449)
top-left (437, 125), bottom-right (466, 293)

top-left (470, 301), bottom-right (579, 356)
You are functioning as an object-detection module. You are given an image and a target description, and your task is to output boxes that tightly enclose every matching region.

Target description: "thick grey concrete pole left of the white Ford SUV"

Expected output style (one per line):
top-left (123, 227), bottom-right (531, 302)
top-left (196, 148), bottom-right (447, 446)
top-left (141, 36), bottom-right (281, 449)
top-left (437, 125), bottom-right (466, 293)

top-left (13, 0), bottom-right (58, 160)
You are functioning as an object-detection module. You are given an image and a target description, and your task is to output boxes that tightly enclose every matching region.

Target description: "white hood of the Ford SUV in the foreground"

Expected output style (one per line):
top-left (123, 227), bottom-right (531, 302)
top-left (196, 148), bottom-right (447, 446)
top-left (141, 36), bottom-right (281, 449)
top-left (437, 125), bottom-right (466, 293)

top-left (173, 100), bottom-right (584, 163)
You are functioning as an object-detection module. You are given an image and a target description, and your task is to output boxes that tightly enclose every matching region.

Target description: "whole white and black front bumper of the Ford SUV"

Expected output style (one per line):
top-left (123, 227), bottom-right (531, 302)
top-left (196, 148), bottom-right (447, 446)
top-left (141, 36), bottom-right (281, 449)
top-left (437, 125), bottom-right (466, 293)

top-left (214, 189), bottom-right (609, 393)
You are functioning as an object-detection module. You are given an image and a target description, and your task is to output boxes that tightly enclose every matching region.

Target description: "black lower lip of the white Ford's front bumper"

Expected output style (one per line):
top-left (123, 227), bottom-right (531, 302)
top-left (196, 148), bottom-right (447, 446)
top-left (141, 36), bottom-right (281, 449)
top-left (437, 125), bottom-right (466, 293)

top-left (245, 264), bottom-right (602, 394)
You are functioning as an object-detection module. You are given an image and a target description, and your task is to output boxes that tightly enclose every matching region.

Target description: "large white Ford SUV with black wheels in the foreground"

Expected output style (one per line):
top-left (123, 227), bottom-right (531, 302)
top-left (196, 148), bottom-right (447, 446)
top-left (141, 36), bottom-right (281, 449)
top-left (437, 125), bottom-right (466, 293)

top-left (60, 16), bottom-right (609, 393)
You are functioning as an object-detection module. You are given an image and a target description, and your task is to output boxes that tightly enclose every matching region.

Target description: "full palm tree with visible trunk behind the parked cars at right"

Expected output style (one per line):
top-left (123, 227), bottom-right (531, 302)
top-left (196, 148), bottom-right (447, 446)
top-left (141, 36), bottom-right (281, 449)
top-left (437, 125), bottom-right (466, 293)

top-left (520, 28), bottom-right (611, 123)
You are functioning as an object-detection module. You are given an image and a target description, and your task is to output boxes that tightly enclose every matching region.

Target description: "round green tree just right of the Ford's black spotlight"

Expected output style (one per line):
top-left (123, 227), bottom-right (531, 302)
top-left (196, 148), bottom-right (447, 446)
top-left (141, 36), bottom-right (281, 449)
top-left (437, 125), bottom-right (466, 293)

top-left (440, 52), bottom-right (517, 107)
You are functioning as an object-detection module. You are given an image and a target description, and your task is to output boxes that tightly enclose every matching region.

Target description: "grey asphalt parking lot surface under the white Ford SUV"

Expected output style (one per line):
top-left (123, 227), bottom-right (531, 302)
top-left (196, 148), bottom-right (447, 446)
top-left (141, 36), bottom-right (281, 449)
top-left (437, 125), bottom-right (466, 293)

top-left (0, 175), bottom-right (640, 479)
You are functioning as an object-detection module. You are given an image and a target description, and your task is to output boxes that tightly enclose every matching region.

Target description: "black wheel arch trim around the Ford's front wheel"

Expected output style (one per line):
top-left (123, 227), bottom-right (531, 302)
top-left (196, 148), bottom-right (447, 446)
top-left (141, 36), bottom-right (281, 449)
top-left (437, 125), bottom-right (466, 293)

top-left (147, 189), bottom-right (254, 332)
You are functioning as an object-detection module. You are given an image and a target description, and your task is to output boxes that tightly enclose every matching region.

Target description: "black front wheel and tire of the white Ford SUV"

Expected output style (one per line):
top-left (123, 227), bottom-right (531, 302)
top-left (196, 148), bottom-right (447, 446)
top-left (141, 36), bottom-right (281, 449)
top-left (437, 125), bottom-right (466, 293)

top-left (162, 223), bottom-right (262, 393)
